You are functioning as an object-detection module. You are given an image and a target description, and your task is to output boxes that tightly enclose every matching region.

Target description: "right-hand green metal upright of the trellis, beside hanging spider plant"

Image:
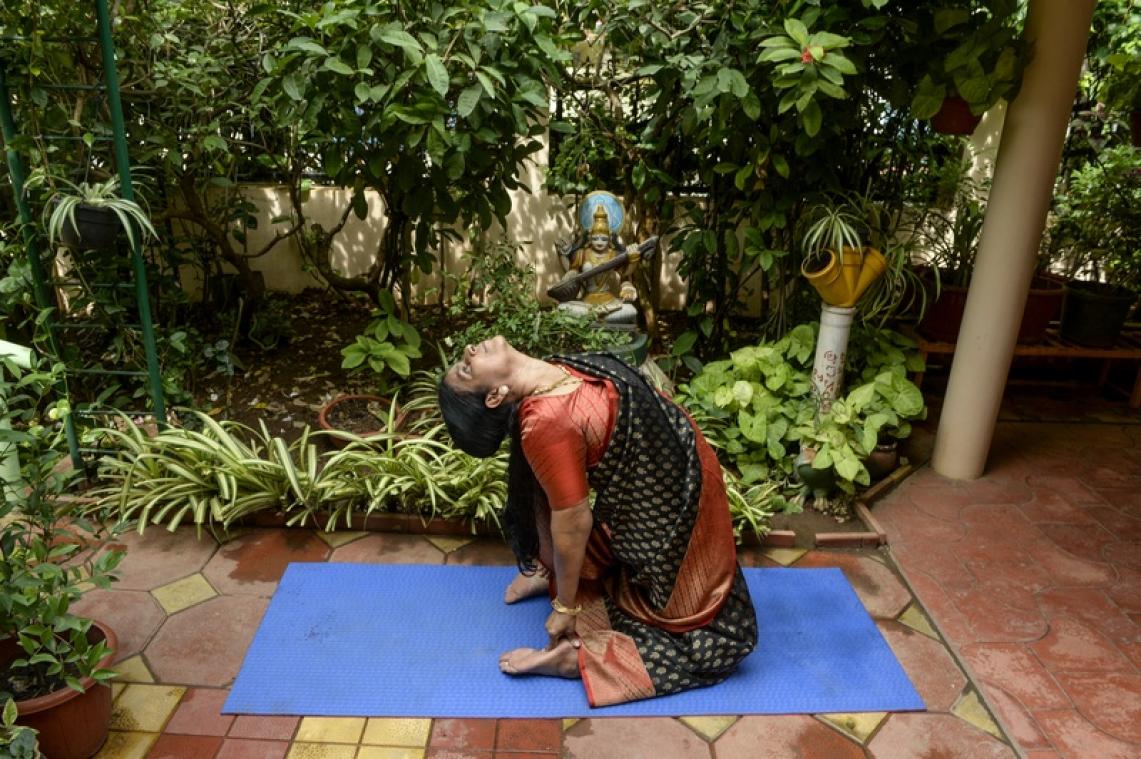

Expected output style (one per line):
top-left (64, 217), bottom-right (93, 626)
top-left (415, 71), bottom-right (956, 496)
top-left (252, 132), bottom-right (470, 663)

top-left (95, 0), bottom-right (167, 427)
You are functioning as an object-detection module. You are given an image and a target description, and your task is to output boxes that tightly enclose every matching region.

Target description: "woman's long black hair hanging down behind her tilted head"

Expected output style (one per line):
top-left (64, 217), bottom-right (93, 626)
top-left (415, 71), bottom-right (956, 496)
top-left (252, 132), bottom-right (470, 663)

top-left (438, 378), bottom-right (543, 574)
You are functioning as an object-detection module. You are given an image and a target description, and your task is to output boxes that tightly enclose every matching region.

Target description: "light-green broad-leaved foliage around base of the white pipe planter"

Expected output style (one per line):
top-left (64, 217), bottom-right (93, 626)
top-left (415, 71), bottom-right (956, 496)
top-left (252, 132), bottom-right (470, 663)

top-left (679, 324), bottom-right (925, 492)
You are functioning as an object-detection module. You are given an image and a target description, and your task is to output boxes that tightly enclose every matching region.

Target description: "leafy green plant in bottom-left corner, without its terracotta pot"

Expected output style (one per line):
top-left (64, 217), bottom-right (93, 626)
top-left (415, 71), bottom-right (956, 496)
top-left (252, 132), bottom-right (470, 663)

top-left (0, 358), bottom-right (123, 700)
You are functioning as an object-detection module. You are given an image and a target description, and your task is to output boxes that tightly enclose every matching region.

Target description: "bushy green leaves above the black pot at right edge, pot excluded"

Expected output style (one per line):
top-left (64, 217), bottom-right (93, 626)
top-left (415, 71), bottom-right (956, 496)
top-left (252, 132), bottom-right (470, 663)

top-left (1047, 146), bottom-right (1141, 292)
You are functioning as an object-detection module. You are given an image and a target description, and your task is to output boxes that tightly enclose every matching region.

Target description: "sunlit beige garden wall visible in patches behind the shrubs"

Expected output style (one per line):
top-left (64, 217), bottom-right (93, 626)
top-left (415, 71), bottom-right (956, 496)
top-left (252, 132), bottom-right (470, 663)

top-left (196, 136), bottom-right (685, 308)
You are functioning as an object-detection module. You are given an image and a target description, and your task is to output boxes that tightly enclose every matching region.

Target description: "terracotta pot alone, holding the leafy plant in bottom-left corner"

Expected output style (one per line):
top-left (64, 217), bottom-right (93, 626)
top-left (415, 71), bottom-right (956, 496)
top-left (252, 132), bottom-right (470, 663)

top-left (0, 621), bottom-right (119, 759)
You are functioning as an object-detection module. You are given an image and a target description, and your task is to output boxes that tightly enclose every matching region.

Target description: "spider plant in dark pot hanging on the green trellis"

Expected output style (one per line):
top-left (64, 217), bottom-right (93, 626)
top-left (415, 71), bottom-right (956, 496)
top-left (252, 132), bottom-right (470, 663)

top-left (26, 171), bottom-right (156, 251)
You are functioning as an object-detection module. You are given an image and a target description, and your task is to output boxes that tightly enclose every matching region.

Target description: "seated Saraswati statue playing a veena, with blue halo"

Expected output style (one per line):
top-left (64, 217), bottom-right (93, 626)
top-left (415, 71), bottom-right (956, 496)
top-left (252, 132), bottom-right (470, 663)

top-left (547, 191), bottom-right (657, 330)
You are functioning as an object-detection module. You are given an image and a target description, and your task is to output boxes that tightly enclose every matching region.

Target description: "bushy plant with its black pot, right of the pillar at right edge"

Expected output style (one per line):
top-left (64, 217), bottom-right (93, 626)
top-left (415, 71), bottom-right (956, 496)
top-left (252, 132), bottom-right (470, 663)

top-left (1049, 146), bottom-right (1141, 347)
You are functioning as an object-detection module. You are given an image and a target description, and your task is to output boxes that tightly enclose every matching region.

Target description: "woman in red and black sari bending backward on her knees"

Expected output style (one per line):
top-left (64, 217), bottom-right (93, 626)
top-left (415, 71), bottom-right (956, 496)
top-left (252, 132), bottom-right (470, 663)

top-left (439, 337), bottom-right (756, 706)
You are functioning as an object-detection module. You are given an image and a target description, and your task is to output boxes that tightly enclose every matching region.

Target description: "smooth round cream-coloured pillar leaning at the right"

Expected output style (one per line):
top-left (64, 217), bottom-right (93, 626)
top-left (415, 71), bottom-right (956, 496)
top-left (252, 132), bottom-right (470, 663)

top-left (932, 0), bottom-right (1097, 479)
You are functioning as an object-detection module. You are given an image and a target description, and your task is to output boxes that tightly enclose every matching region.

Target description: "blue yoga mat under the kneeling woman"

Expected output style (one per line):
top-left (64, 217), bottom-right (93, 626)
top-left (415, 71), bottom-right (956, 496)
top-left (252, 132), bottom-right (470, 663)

top-left (222, 564), bottom-right (924, 718)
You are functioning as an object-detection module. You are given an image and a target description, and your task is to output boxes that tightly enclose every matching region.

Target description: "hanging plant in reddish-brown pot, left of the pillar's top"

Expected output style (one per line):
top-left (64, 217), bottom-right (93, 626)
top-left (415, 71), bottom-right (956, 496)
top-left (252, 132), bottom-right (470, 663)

top-left (912, 0), bottom-right (1029, 135)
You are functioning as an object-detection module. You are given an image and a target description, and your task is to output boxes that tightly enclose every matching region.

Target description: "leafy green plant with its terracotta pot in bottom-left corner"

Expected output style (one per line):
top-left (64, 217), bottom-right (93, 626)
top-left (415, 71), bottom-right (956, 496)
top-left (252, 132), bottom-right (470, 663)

top-left (0, 360), bottom-right (122, 759)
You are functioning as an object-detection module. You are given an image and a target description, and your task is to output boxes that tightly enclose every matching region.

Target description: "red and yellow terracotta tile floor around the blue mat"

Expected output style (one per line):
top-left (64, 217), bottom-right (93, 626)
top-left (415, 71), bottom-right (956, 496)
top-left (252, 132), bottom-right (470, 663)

top-left (80, 423), bottom-right (1141, 759)
